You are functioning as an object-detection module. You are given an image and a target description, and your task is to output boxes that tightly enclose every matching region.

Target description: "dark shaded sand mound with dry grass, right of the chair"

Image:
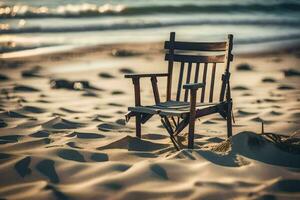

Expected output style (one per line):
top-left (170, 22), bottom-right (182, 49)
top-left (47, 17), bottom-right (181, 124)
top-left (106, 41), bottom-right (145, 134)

top-left (196, 132), bottom-right (300, 168)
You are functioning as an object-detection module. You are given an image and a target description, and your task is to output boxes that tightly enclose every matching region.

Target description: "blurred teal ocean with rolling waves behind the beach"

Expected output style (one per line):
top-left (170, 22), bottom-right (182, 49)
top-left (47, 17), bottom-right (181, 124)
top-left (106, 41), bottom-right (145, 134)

top-left (0, 0), bottom-right (300, 54)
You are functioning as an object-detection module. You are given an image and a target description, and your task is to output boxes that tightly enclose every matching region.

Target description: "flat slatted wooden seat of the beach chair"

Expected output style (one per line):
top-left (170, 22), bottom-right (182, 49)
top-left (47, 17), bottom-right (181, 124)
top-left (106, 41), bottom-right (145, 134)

top-left (128, 101), bottom-right (220, 116)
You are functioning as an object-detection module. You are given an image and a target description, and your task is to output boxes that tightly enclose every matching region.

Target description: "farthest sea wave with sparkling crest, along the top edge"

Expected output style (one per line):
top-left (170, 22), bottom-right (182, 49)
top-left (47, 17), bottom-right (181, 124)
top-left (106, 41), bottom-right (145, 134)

top-left (0, 2), bottom-right (300, 18)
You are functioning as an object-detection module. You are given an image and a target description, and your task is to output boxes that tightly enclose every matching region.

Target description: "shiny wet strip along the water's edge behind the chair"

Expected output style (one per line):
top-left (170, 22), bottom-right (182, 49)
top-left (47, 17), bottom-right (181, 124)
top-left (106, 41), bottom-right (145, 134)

top-left (0, 37), bottom-right (300, 60)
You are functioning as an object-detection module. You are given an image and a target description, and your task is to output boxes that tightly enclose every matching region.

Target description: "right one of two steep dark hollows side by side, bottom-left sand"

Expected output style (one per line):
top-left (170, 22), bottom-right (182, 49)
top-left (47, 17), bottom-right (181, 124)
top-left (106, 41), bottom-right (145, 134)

top-left (36, 160), bottom-right (59, 183)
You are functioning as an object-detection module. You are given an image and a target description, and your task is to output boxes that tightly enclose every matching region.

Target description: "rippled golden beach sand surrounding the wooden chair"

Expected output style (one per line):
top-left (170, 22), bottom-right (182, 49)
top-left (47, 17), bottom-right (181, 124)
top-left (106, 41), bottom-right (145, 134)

top-left (0, 43), bottom-right (300, 199)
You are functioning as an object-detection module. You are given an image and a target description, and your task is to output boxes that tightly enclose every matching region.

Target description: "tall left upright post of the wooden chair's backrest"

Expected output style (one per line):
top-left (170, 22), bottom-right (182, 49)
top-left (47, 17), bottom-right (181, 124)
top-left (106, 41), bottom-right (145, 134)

top-left (167, 32), bottom-right (175, 101)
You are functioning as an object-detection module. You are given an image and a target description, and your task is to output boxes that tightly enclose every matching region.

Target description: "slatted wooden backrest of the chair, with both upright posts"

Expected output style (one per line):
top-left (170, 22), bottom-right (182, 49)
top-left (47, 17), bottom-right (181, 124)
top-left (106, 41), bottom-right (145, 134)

top-left (164, 32), bottom-right (233, 102)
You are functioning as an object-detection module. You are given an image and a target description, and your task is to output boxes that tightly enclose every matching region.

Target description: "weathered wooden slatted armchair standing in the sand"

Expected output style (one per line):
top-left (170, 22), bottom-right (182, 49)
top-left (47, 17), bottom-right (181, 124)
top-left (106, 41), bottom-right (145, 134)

top-left (125, 32), bottom-right (233, 149)
